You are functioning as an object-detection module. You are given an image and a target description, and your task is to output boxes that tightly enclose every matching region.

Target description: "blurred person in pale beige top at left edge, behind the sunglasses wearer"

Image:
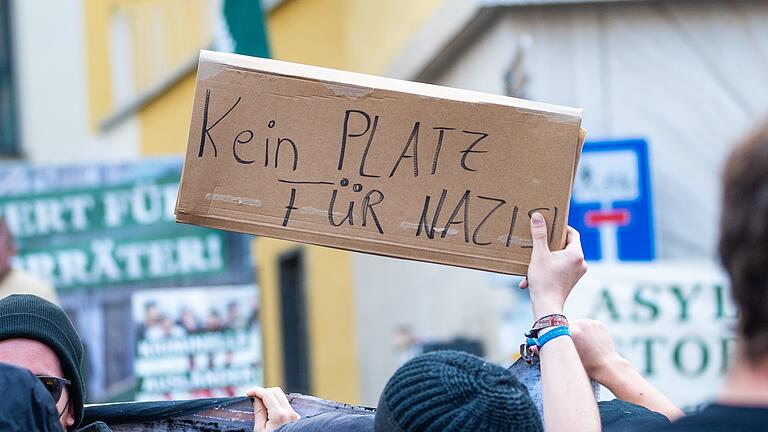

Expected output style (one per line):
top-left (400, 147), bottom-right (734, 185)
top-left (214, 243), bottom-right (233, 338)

top-left (0, 218), bottom-right (59, 303)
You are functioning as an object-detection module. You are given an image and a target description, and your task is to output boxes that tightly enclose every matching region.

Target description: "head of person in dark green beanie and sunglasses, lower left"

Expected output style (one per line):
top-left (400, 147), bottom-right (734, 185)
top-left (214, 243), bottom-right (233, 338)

top-left (0, 294), bottom-right (85, 430)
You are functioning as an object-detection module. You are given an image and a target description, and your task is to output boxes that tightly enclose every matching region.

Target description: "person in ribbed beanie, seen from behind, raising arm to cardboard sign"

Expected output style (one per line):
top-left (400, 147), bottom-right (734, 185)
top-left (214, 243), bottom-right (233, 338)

top-left (249, 213), bottom-right (600, 432)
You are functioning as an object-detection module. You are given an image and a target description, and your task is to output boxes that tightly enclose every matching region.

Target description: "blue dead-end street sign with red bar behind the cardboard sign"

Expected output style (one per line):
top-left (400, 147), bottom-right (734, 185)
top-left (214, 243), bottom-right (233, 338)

top-left (568, 139), bottom-right (656, 261)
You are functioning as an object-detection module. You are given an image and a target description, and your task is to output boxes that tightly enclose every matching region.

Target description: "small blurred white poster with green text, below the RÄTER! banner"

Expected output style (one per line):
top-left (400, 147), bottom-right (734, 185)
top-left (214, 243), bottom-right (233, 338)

top-left (132, 285), bottom-right (263, 401)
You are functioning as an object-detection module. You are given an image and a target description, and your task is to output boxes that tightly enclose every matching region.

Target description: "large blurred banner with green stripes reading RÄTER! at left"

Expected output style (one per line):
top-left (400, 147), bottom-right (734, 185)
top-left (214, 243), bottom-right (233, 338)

top-left (0, 158), bottom-right (258, 401)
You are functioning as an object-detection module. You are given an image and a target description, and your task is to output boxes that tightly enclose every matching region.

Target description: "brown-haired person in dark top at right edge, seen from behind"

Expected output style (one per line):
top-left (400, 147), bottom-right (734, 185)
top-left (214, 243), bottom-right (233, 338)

top-left (644, 122), bottom-right (768, 432)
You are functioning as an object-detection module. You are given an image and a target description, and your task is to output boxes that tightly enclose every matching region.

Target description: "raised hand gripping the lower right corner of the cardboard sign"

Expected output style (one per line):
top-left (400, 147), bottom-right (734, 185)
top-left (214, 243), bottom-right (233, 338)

top-left (520, 213), bottom-right (587, 319)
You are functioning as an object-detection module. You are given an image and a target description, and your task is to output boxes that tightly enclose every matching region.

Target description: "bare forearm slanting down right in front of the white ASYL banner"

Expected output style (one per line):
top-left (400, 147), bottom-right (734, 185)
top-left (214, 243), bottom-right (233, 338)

top-left (595, 359), bottom-right (684, 420)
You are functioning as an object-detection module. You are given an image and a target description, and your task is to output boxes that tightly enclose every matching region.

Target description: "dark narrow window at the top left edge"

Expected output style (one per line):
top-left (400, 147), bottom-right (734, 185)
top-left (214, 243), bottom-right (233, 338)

top-left (0, 0), bottom-right (17, 156)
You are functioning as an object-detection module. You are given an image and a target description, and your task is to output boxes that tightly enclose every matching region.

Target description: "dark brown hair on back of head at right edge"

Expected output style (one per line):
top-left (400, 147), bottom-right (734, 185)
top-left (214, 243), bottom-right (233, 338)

top-left (719, 118), bottom-right (768, 362)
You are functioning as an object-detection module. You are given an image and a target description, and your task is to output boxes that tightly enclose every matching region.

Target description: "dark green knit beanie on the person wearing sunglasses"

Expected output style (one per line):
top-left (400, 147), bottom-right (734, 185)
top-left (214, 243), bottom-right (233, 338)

top-left (0, 294), bottom-right (85, 427)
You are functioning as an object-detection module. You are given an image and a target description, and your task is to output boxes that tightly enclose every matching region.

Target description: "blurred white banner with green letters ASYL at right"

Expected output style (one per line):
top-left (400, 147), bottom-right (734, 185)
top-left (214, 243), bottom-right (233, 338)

top-left (566, 263), bottom-right (736, 406)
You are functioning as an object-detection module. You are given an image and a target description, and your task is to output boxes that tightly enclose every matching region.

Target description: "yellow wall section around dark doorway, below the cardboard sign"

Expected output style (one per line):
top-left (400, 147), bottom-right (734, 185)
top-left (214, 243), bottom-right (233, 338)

top-left (254, 238), bottom-right (360, 403)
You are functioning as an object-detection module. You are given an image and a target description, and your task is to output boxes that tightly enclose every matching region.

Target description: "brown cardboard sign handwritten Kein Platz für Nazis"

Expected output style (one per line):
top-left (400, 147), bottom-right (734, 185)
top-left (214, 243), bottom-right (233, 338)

top-left (176, 51), bottom-right (584, 274)
